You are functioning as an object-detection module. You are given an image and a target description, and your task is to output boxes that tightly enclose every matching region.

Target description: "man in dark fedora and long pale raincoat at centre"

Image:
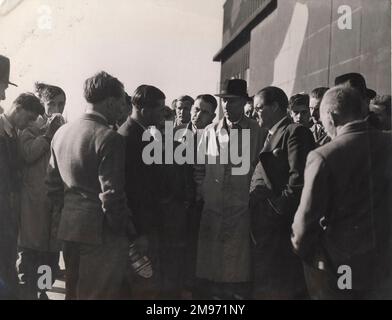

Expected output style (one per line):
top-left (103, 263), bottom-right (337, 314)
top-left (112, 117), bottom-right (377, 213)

top-left (196, 79), bottom-right (262, 299)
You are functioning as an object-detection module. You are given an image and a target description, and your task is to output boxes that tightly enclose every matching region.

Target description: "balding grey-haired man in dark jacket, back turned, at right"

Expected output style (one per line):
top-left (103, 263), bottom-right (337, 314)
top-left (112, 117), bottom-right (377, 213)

top-left (292, 87), bottom-right (392, 299)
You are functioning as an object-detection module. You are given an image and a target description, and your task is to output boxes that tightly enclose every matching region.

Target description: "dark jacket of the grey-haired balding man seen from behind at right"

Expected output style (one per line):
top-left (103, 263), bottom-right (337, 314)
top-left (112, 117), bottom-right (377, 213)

top-left (292, 121), bottom-right (392, 289)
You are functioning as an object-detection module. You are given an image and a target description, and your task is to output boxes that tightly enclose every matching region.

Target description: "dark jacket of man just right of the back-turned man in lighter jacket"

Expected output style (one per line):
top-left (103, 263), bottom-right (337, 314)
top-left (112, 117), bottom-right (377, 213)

top-left (118, 117), bottom-right (162, 234)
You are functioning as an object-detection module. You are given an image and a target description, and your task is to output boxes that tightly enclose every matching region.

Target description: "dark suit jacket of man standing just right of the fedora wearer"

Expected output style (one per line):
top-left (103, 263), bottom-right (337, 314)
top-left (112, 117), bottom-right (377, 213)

top-left (251, 117), bottom-right (315, 226)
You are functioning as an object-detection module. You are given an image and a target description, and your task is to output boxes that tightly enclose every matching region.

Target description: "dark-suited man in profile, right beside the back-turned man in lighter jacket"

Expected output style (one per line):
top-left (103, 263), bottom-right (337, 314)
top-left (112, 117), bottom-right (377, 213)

top-left (118, 85), bottom-right (165, 299)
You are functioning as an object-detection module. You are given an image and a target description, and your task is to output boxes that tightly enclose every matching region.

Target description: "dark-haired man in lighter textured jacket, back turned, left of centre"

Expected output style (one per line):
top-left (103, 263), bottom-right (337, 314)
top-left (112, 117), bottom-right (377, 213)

top-left (48, 72), bottom-right (134, 300)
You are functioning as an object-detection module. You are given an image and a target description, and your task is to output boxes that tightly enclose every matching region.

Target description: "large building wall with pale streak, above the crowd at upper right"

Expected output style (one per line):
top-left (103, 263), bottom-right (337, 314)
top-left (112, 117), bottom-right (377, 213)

top-left (245, 0), bottom-right (391, 95)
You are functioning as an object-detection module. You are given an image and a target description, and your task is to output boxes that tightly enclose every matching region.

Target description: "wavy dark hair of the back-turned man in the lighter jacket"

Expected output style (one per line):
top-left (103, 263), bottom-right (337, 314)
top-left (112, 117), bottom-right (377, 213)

top-left (84, 71), bottom-right (124, 104)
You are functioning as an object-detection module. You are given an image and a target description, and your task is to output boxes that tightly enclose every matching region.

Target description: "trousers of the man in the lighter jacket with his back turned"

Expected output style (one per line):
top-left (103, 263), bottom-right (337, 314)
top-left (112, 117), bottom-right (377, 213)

top-left (63, 235), bottom-right (129, 300)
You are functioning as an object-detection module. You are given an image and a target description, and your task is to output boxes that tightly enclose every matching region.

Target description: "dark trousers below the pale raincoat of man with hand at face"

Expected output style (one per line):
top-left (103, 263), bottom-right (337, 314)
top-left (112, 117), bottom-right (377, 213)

top-left (19, 248), bottom-right (60, 300)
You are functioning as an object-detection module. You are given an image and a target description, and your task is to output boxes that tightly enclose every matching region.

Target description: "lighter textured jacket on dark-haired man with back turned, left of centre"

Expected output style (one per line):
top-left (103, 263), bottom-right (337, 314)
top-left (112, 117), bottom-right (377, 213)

top-left (47, 114), bottom-right (134, 244)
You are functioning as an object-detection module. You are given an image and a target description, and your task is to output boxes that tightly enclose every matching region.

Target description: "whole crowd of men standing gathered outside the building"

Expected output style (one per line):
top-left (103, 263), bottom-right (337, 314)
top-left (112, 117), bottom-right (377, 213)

top-left (0, 52), bottom-right (392, 300)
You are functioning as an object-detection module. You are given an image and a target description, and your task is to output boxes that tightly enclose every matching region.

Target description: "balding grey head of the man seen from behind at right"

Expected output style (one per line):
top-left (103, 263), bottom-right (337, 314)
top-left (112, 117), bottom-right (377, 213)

top-left (320, 86), bottom-right (364, 138)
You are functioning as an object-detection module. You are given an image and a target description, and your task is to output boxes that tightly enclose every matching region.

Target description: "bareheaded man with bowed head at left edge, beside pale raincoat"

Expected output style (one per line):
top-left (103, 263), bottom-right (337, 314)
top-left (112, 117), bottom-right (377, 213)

top-left (0, 93), bottom-right (45, 299)
